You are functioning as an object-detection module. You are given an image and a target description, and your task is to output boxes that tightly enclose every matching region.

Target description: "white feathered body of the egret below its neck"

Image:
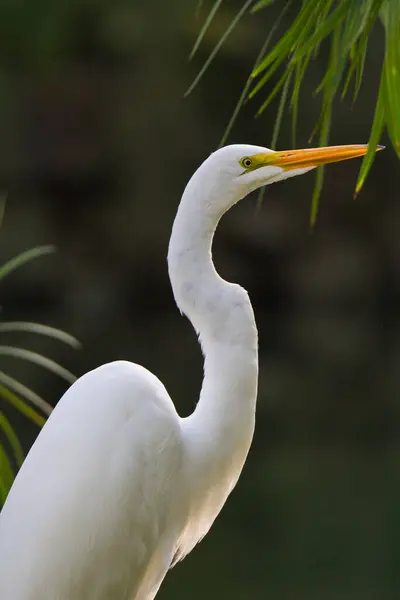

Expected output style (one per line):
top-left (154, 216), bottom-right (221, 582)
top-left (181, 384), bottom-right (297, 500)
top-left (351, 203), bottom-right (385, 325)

top-left (0, 361), bottom-right (183, 600)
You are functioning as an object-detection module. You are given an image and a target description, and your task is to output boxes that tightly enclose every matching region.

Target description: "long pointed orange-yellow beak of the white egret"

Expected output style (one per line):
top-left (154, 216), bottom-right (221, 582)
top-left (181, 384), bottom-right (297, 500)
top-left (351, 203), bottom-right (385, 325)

top-left (252, 144), bottom-right (385, 171)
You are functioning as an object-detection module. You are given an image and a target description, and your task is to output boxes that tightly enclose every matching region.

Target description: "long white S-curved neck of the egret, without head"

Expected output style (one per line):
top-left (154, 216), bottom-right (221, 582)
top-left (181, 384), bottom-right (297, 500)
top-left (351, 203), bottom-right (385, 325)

top-left (168, 177), bottom-right (258, 548)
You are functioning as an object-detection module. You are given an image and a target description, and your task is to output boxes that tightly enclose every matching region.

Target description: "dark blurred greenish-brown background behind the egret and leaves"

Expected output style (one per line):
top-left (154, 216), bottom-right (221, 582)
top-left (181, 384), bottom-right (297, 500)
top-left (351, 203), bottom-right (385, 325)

top-left (0, 0), bottom-right (400, 600)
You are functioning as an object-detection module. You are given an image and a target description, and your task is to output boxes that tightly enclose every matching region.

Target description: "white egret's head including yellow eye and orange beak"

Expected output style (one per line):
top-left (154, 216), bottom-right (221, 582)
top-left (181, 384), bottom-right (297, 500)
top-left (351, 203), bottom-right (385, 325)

top-left (195, 144), bottom-right (383, 218)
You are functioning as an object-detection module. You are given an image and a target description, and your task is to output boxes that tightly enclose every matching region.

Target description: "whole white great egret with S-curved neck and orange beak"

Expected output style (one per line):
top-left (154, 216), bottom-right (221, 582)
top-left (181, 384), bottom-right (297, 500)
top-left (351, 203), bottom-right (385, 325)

top-left (0, 145), bottom-right (382, 600)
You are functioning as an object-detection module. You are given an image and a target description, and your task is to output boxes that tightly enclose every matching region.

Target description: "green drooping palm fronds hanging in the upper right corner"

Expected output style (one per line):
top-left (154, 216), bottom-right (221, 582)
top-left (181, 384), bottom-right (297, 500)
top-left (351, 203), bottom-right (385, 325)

top-left (190, 0), bottom-right (400, 224)
